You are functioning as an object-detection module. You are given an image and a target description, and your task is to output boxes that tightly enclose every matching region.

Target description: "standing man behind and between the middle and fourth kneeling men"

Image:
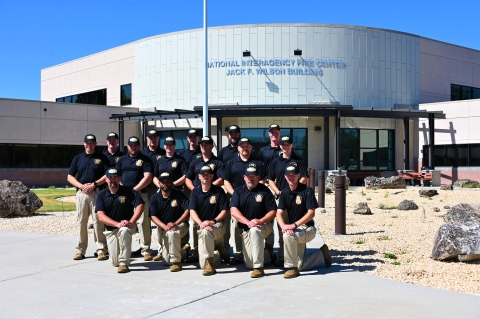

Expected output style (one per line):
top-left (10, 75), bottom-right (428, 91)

top-left (223, 137), bottom-right (268, 265)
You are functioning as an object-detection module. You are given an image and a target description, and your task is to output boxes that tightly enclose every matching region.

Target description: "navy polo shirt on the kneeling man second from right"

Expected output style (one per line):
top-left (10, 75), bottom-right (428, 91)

top-left (230, 183), bottom-right (277, 230)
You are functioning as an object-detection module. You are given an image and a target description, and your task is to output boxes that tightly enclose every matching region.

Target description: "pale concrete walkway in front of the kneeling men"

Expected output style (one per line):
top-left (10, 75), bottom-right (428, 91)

top-left (0, 232), bottom-right (480, 318)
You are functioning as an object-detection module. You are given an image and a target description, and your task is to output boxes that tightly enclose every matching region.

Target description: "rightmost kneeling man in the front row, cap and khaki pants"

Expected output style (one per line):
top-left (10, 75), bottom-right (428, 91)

top-left (277, 165), bottom-right (332, 278)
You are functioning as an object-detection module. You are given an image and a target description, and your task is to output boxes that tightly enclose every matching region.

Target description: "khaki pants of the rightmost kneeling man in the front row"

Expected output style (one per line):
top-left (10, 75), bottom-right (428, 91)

top-left (283, 225), bottom-right (325, 270)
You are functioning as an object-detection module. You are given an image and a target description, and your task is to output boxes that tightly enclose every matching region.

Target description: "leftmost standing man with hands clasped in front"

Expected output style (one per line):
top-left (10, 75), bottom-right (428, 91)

top-left (67, 134), bottom-right (108, 260)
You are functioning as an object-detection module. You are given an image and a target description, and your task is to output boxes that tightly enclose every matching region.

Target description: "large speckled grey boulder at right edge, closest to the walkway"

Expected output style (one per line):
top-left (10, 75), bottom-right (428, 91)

top-left (432, 222), bottom-right (480, 262)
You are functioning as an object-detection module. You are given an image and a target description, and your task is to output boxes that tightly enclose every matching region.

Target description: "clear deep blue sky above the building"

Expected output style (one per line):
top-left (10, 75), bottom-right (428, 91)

top-left (0, 0), bottom-right (480, 100)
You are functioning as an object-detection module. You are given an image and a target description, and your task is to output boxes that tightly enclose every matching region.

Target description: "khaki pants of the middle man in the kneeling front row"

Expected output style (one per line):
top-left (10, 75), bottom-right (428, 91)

top-left (197, 223), bottom-right (226, 269)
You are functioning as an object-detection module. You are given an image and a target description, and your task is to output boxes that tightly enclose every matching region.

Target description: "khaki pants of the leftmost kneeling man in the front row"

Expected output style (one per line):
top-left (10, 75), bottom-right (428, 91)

top-left (104, 225), bottom-right (136, 267)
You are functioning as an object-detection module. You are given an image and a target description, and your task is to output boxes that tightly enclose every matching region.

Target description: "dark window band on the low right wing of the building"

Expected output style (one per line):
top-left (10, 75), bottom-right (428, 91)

top-left (423, 144), bottom-right (480, 167)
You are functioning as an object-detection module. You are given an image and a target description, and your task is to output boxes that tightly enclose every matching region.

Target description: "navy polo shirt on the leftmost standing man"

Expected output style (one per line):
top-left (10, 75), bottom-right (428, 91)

top-left (68, 152), bottom-right (109, 184)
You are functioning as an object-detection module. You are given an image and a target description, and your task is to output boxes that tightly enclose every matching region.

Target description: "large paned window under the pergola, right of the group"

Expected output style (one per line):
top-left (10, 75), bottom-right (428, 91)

top-left (340, 128), bottom-right (395, 171)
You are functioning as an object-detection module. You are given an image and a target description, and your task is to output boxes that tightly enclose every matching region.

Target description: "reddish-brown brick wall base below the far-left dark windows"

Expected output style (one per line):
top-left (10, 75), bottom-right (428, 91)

top-left (0, 168), bottom-right (70, 188)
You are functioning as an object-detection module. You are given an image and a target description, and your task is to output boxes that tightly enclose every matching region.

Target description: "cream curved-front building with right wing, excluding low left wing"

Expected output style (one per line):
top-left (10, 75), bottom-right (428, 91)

top-left (0, 24), bottom-right (480, 188)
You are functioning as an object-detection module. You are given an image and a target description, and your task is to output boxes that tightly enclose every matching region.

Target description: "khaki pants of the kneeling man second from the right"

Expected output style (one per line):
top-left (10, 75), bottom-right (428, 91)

top-left (242, 222), bottom-right (273, 269)
